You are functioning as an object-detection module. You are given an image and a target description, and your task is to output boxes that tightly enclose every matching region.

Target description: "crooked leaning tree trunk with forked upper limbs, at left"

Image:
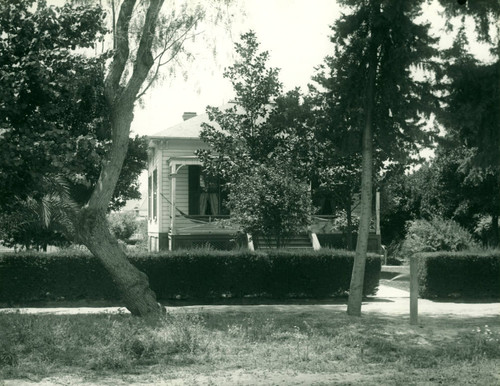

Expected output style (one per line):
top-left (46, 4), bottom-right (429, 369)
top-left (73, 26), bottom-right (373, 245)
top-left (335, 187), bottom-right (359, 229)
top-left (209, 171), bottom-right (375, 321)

top-left (72, 0), bottom-right (163, 316)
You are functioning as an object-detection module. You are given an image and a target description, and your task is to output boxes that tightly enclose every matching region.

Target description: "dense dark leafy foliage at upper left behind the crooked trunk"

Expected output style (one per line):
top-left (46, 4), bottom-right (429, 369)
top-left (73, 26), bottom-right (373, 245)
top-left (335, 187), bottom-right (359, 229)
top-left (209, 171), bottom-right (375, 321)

top-left (0, 1), bottom-right (147, 212)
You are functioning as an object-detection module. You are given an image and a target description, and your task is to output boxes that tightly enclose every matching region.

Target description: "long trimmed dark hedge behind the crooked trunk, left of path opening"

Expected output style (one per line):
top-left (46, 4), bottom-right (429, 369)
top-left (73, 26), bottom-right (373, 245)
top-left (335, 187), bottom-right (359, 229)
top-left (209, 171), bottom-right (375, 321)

top-left (0, 250), bottom-right (381, 303)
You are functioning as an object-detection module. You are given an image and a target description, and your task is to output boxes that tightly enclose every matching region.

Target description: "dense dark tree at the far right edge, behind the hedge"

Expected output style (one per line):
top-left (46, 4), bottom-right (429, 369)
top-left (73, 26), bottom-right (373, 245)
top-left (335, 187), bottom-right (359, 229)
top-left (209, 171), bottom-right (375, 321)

top-left (437, 0), bottom-right (500, 246)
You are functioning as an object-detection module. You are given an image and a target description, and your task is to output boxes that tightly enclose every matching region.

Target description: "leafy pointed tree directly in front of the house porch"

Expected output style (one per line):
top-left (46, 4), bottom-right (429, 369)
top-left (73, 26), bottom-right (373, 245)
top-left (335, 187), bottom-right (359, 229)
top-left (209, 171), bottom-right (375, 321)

top-left (197, 32), bottom-right (312, 246)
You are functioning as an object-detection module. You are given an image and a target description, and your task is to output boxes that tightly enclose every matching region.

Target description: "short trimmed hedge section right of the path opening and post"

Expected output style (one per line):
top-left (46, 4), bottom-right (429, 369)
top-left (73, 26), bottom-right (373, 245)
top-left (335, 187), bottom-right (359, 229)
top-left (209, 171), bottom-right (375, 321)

top-left (416, 251), bottom-right (500, 299)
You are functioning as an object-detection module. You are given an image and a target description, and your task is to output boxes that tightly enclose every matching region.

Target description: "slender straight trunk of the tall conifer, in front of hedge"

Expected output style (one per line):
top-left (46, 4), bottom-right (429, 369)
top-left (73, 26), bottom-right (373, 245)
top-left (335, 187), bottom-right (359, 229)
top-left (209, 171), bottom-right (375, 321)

top-left (347, 2), bottom-right (380, 316)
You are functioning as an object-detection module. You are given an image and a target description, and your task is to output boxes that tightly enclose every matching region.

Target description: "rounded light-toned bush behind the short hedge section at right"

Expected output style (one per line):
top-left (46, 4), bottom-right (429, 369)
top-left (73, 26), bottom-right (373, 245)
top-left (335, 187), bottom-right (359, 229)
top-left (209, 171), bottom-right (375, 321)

top-left (401, 217), bottom-right (477, 257)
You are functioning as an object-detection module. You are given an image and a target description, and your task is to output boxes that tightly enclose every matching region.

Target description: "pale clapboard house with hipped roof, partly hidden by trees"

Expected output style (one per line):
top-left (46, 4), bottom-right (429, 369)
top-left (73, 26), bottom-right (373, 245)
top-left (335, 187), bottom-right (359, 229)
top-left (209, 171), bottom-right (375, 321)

top-left (147, 105), bottom-right (380, 251)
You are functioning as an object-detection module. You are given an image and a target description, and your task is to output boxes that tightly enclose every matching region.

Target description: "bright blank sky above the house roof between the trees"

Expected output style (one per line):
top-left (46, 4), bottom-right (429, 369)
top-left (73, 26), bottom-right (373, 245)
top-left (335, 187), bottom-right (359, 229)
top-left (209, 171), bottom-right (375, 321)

top-left (132, 0), bottom-right (339, 135)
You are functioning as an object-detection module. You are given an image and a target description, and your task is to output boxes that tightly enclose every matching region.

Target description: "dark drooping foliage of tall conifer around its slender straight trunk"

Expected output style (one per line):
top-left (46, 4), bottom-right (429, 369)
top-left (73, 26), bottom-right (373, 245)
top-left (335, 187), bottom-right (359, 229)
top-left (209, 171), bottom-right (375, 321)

top-left (312, 1), bottom-right (436, 170)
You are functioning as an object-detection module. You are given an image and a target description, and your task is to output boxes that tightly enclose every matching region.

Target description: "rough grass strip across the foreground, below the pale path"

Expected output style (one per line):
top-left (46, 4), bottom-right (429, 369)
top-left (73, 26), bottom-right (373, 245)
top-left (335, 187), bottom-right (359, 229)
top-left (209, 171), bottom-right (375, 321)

top-left (0, 307), bottom-right (500, 385)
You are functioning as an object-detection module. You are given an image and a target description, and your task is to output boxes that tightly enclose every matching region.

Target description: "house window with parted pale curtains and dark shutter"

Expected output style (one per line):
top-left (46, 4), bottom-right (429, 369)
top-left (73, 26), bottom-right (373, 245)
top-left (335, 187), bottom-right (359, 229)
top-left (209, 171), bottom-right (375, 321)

top-left (188, 165), bottom-right (229, 216)
